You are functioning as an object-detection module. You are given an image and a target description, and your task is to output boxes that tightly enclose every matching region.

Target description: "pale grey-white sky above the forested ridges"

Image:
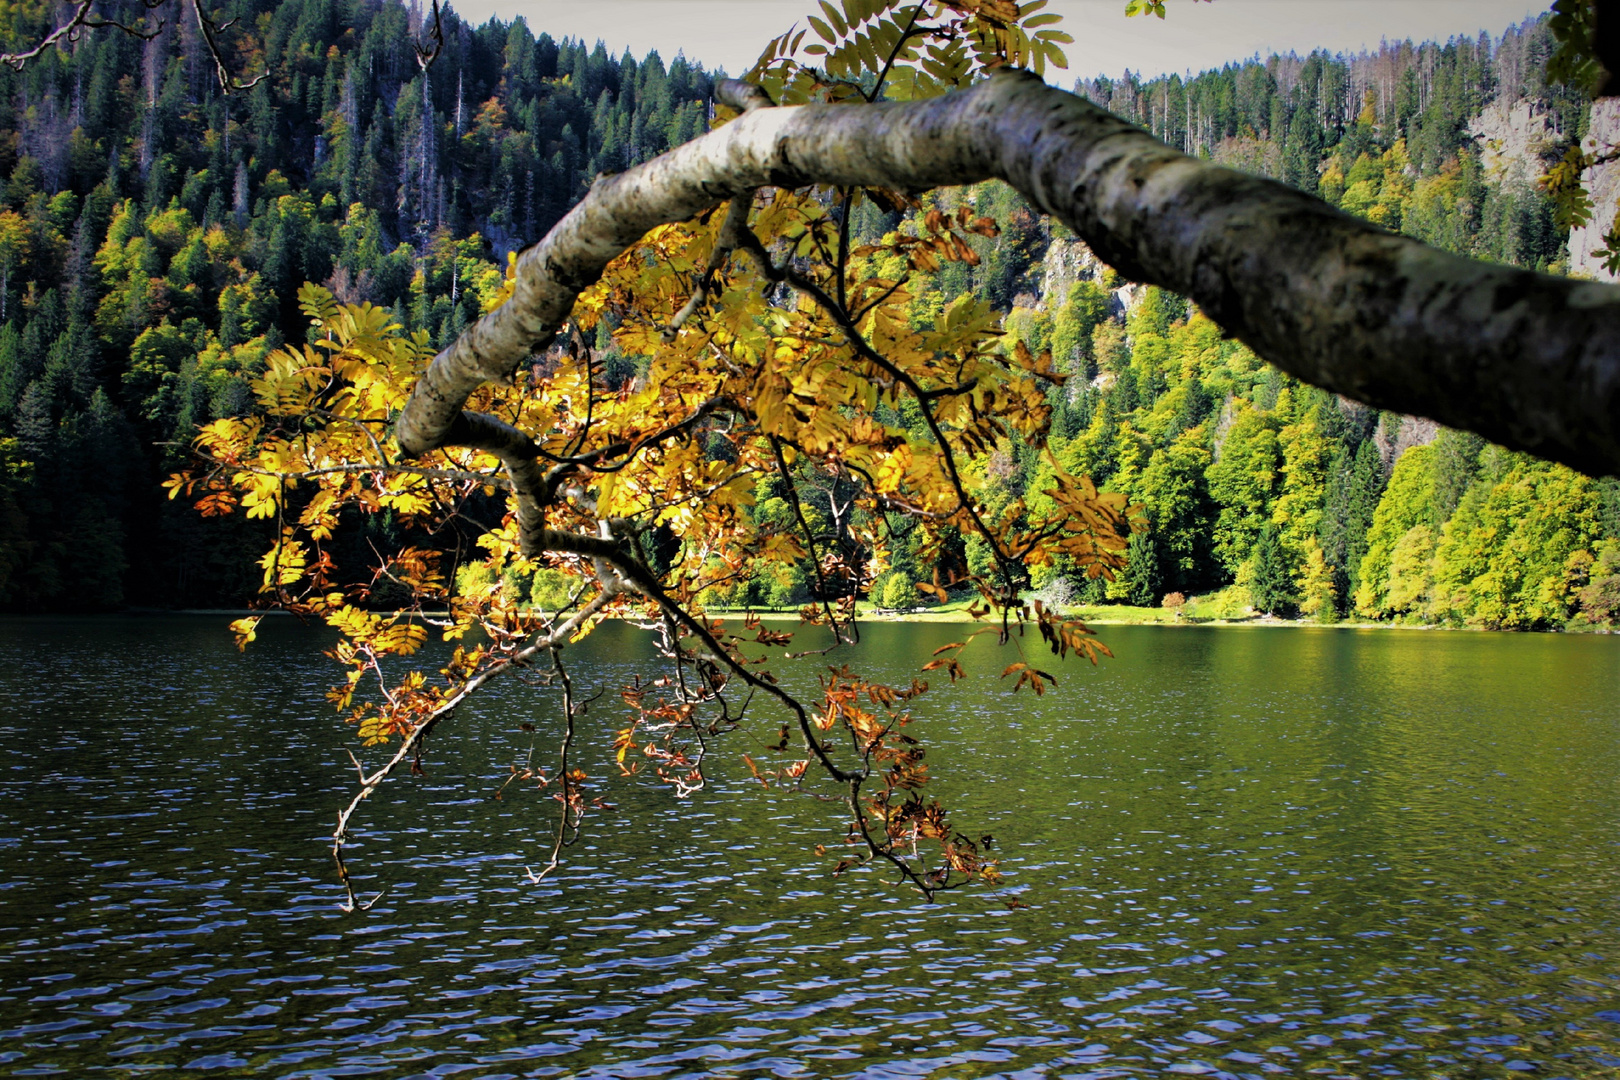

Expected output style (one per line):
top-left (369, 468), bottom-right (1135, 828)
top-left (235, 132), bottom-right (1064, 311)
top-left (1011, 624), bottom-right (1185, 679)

top-left (452, 0), bottom-right (1550, 86)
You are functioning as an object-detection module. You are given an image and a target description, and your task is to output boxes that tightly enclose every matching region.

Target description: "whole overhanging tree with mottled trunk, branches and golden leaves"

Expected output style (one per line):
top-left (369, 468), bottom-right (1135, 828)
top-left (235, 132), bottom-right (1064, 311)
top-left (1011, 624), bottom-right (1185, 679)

top-left (157, 0), bottom-right (1620, 899)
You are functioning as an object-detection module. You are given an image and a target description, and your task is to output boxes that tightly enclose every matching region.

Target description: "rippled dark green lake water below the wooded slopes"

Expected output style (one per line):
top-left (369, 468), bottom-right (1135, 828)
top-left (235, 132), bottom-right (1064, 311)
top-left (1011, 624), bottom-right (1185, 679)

top-left (0, 619), bottom-right (1620, 1078)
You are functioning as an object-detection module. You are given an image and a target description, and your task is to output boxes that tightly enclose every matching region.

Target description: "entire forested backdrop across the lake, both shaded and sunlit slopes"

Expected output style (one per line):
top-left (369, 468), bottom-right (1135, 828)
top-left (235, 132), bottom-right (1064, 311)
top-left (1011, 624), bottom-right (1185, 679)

top-left (0, 0), bottom-right (1620, 628)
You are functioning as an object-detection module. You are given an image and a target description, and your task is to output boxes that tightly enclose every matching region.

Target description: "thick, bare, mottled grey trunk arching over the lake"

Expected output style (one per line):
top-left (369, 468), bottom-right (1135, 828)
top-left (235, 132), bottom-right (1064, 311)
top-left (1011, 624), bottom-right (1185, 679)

top-left (397, 73), bottom-right (1620, 474)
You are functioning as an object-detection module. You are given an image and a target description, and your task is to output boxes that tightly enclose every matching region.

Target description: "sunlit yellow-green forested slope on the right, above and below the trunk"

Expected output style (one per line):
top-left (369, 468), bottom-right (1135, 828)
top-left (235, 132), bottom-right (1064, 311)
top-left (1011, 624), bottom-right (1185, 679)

top-left (1013, 23), bottom-right (1620, 628)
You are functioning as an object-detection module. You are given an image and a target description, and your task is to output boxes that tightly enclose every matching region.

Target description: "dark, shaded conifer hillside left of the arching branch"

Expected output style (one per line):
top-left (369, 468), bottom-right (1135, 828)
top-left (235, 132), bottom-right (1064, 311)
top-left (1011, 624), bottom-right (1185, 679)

top-left (0, 0), bottom-right (711, 610)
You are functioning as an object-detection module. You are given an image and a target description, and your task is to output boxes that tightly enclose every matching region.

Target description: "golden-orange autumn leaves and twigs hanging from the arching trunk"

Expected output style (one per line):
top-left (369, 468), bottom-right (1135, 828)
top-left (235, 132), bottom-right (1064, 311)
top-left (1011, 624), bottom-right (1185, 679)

top-left (170, 0), bottom-right (1140, 902)
